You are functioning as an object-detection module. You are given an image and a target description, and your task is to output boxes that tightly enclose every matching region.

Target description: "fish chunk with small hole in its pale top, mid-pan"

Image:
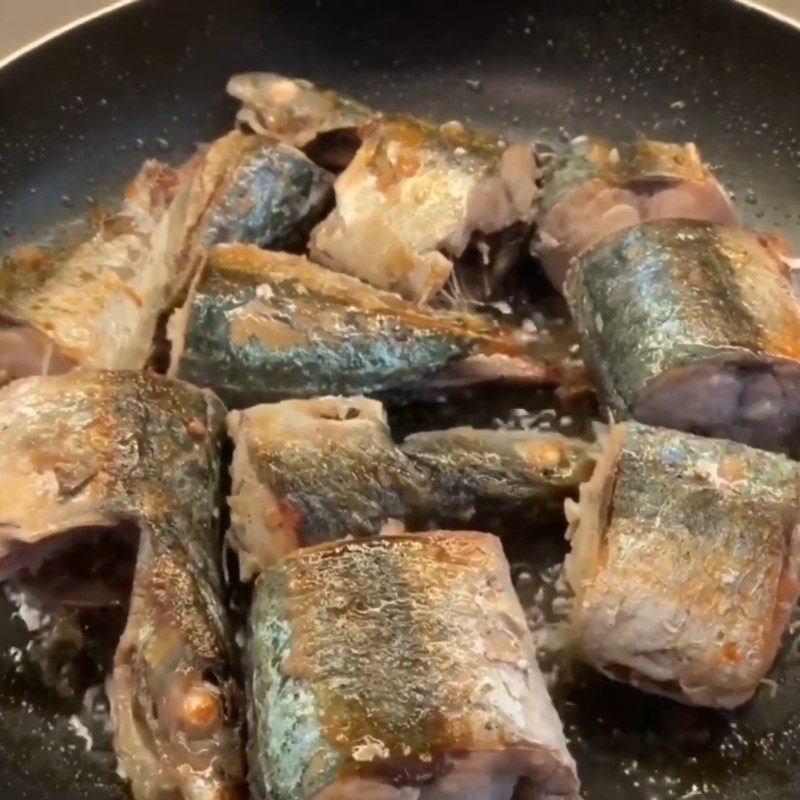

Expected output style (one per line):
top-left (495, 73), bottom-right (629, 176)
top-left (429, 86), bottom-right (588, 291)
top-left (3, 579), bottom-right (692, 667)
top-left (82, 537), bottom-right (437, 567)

top-left (228, 397), bottom-right (432, 579)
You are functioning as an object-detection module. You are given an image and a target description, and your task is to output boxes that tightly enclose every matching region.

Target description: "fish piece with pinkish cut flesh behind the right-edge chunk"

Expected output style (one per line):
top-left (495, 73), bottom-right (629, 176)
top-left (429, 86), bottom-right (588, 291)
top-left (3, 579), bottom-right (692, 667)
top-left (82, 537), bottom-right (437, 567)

top-left (534, 136), bottom-right (739, 291)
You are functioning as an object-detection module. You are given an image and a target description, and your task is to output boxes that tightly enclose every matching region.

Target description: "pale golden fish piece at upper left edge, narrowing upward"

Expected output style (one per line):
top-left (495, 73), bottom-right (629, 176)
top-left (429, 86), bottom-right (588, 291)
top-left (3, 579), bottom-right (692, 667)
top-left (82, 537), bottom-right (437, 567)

top-left (0, 161), bottom-right (182, 383)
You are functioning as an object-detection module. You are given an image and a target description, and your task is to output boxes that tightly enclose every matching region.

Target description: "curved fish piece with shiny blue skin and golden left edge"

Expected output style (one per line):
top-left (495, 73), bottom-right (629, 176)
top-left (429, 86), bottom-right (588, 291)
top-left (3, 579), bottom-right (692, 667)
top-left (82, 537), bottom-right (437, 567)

top-left (158, 131), bottom-right (333, 297)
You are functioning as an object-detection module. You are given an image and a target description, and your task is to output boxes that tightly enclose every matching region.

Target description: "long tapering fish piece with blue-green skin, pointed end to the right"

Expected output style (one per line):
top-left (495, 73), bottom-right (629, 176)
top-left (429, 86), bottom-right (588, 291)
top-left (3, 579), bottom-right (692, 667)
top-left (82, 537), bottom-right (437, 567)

top-left (169, 245), bottom-right (560, 408)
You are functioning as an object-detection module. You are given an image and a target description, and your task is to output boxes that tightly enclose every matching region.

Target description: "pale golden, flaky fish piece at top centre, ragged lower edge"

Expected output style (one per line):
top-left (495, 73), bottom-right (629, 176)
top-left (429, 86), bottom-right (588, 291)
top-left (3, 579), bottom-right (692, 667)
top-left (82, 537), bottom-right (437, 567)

top-left (310, 116), bottom-right (538, 302)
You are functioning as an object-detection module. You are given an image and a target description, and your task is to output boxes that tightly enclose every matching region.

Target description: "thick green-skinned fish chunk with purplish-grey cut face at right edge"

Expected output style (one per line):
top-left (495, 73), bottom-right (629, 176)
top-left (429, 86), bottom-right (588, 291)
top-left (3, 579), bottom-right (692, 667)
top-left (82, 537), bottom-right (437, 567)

top-left (567, 220), bottom-right (800, 457)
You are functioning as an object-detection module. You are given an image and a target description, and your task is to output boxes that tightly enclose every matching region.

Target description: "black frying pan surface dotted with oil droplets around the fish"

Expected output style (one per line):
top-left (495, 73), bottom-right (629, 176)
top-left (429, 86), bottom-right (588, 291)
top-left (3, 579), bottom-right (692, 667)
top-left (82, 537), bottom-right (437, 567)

top-left (0, 0), bottom-right (800, 800)
